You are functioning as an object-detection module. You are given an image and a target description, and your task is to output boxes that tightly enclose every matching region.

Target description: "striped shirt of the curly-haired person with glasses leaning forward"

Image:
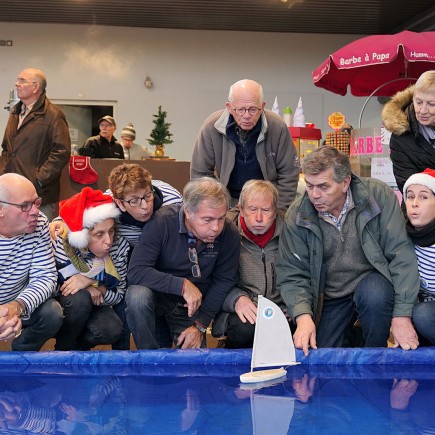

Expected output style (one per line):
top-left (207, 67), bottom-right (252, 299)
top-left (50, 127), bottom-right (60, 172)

top-left (108, 180), bottom-right (183, 246)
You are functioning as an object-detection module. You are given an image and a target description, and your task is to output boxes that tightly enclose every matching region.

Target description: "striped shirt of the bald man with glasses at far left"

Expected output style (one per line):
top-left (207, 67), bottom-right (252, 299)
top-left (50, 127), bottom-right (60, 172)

top-left (0, 212), bottom-right (57, 319)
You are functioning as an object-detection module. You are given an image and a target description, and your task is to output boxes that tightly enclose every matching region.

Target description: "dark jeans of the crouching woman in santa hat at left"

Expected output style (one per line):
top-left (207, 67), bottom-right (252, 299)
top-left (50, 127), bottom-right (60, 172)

top-left (55, 289), bottom-right (122, 350)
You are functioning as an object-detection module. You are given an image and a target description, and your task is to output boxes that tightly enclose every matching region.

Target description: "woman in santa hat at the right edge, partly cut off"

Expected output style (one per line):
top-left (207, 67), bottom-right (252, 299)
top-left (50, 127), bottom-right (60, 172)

top-left (403, 169), bottom-right (435, 345)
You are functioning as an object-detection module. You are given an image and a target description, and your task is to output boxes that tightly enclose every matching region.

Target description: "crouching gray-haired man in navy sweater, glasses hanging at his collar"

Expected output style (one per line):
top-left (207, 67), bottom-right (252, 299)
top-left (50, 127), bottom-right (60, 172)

top-left (125, 177), bottom-right (240, 349)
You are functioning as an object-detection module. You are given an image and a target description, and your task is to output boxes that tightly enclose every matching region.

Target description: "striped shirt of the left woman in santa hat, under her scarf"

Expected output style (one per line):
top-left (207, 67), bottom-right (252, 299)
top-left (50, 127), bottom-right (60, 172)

top-left (53, 236), bottom-right (130, 305)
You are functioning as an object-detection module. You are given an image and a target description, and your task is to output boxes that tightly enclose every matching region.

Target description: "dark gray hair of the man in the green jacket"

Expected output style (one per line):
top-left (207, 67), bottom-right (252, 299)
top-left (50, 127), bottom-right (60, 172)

top-left (302, 145), bottom-right (352, 183)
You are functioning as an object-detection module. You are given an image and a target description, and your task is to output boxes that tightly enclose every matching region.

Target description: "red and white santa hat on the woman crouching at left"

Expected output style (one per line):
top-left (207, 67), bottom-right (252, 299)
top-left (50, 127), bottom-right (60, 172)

top-left (59, 187), bottom-right (121, 249)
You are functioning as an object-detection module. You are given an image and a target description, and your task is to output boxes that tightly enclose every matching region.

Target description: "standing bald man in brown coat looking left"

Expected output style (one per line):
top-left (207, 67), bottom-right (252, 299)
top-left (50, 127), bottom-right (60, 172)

top-left (2, 68), bottom-right (71, 220)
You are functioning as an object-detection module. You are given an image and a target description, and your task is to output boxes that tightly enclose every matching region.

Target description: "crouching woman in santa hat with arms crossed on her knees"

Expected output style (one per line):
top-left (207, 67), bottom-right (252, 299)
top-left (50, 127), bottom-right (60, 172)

top-left (54, 187), bottom-right (129, 350)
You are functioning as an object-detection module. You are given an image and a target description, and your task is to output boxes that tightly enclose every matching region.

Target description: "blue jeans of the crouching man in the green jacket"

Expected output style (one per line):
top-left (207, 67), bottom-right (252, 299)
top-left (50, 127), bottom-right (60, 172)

top-left (316, 272), bottom-right (394, 347)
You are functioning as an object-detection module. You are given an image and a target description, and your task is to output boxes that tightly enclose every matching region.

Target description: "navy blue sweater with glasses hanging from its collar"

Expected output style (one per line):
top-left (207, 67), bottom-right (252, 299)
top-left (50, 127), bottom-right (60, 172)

top-left (127, 204), bottom-right (240, 325)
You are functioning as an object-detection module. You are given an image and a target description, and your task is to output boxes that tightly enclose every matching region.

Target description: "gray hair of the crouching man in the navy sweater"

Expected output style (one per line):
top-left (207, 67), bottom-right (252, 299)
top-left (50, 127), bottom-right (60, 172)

top-left (183, 177), bottom-right (231, 214)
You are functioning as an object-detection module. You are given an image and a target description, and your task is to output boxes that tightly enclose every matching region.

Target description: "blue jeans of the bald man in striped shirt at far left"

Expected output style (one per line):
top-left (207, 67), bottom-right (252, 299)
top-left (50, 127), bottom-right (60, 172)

top-left (11, 298), bottom-right (63, 351)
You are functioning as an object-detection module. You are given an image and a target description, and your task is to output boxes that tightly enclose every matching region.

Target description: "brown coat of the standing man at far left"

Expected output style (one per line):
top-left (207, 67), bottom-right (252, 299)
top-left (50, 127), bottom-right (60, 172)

top-left (2, 93), bottom-right (71, 205)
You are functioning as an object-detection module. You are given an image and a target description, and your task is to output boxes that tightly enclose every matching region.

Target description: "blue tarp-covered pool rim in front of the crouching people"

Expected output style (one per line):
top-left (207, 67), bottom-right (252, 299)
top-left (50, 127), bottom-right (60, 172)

top-left (0, 347), bottom-right (435, 366)
